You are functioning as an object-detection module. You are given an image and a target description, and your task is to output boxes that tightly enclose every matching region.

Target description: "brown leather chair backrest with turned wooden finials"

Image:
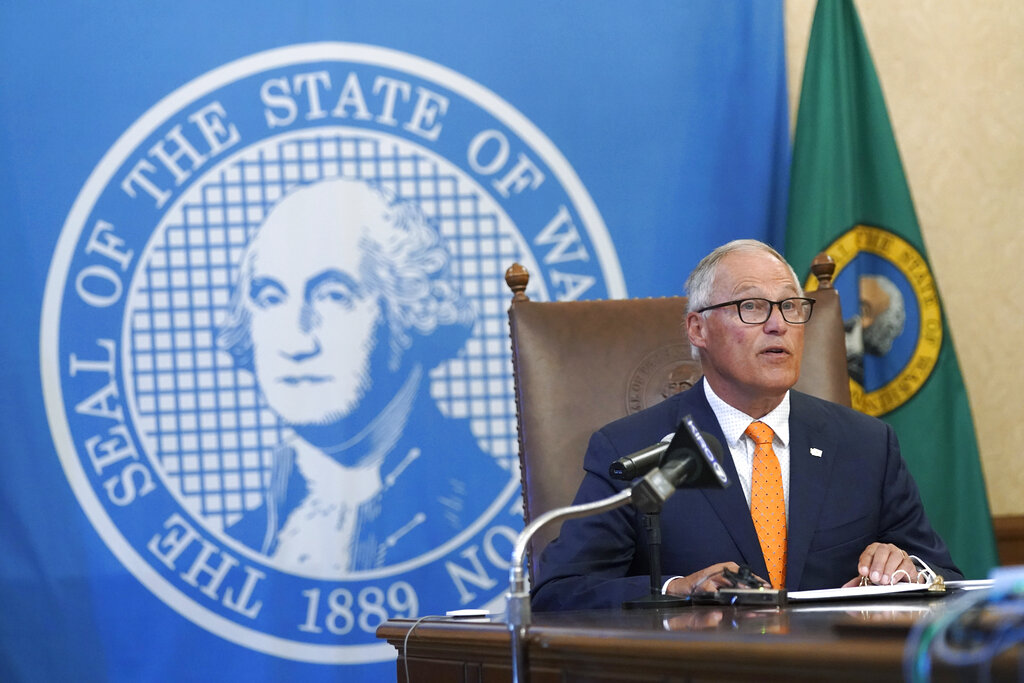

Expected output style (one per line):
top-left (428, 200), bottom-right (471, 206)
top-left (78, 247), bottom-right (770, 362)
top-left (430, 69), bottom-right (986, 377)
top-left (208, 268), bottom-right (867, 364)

top-left (505, 256), bottom-right (850, 574)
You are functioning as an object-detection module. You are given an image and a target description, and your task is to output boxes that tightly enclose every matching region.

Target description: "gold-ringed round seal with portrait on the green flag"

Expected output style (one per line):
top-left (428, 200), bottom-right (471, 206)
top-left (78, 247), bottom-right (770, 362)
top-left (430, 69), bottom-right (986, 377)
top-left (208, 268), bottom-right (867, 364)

top-left (807, 225), bottom-right (942, 417)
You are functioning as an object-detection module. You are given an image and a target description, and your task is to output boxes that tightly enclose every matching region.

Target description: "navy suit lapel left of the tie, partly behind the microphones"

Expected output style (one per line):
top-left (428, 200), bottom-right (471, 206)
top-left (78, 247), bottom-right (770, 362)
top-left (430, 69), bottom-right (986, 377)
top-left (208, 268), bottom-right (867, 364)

top-left (678, 380), bottom-right (768, 577)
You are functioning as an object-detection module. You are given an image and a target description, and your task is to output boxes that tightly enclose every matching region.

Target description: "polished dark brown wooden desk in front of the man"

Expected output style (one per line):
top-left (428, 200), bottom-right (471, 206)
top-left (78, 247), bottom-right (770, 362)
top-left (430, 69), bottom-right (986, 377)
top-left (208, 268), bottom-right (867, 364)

top-left (377, 598), bottom-right (1017, 683)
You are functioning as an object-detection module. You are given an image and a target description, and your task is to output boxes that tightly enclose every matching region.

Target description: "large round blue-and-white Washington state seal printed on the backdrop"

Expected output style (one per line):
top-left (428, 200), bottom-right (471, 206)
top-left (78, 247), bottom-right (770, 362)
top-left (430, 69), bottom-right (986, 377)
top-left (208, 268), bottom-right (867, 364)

top-left (41, 43), bottom-right (625, 664)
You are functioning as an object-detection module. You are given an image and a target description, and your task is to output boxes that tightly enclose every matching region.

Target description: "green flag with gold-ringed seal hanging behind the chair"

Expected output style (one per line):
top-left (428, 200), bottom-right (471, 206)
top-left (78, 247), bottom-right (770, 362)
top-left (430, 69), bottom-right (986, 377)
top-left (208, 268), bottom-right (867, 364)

top-left (785, 0), bottom-right (997, 578)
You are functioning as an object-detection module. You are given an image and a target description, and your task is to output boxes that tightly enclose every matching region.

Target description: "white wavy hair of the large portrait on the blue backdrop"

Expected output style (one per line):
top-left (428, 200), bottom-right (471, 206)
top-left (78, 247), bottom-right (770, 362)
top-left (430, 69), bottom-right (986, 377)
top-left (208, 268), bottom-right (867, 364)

top-left (217, 178), bottom-right (475, 370)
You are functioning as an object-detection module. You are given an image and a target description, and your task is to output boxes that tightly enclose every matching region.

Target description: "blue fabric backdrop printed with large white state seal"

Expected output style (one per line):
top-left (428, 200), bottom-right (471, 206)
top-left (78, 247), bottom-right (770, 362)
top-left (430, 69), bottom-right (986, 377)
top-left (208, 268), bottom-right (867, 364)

top-left (0, 0), bottom-right (788, 681)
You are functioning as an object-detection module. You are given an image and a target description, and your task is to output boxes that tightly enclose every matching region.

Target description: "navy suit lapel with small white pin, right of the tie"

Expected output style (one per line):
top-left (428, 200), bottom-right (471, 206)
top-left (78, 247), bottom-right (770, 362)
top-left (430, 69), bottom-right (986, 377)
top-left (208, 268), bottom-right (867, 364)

top-left (785, 391), bottom-right (838, 590)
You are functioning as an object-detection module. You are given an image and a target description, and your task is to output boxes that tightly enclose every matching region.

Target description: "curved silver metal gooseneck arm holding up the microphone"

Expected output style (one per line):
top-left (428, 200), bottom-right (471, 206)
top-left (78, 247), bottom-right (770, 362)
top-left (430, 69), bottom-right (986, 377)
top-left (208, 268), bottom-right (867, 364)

top-left (505, 488), bottom-right (633, 683)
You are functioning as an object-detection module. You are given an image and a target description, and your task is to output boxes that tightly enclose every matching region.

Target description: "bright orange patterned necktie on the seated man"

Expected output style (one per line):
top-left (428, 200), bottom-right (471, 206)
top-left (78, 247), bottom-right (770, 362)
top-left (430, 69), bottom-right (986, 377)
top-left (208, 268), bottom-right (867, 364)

top-left (746, 422), bottom-right (785, 588)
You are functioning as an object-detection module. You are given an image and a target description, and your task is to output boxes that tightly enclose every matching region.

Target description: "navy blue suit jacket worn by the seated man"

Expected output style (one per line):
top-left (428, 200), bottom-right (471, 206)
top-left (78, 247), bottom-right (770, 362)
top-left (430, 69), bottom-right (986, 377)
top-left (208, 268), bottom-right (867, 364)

top-left (532, 382), bottom-right (962, 610)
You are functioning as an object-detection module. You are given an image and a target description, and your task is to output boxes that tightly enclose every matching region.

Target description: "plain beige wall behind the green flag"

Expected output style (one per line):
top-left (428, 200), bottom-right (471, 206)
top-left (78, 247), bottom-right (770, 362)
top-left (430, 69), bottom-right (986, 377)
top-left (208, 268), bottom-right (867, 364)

top-left (785, 0), bottom-right (1024, 515)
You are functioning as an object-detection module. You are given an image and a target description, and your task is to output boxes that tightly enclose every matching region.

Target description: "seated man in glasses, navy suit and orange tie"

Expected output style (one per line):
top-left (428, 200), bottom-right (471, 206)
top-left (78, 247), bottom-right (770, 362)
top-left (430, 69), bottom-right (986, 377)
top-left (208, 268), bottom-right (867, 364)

top-left (532, 240), bottom-right (961, 610)
